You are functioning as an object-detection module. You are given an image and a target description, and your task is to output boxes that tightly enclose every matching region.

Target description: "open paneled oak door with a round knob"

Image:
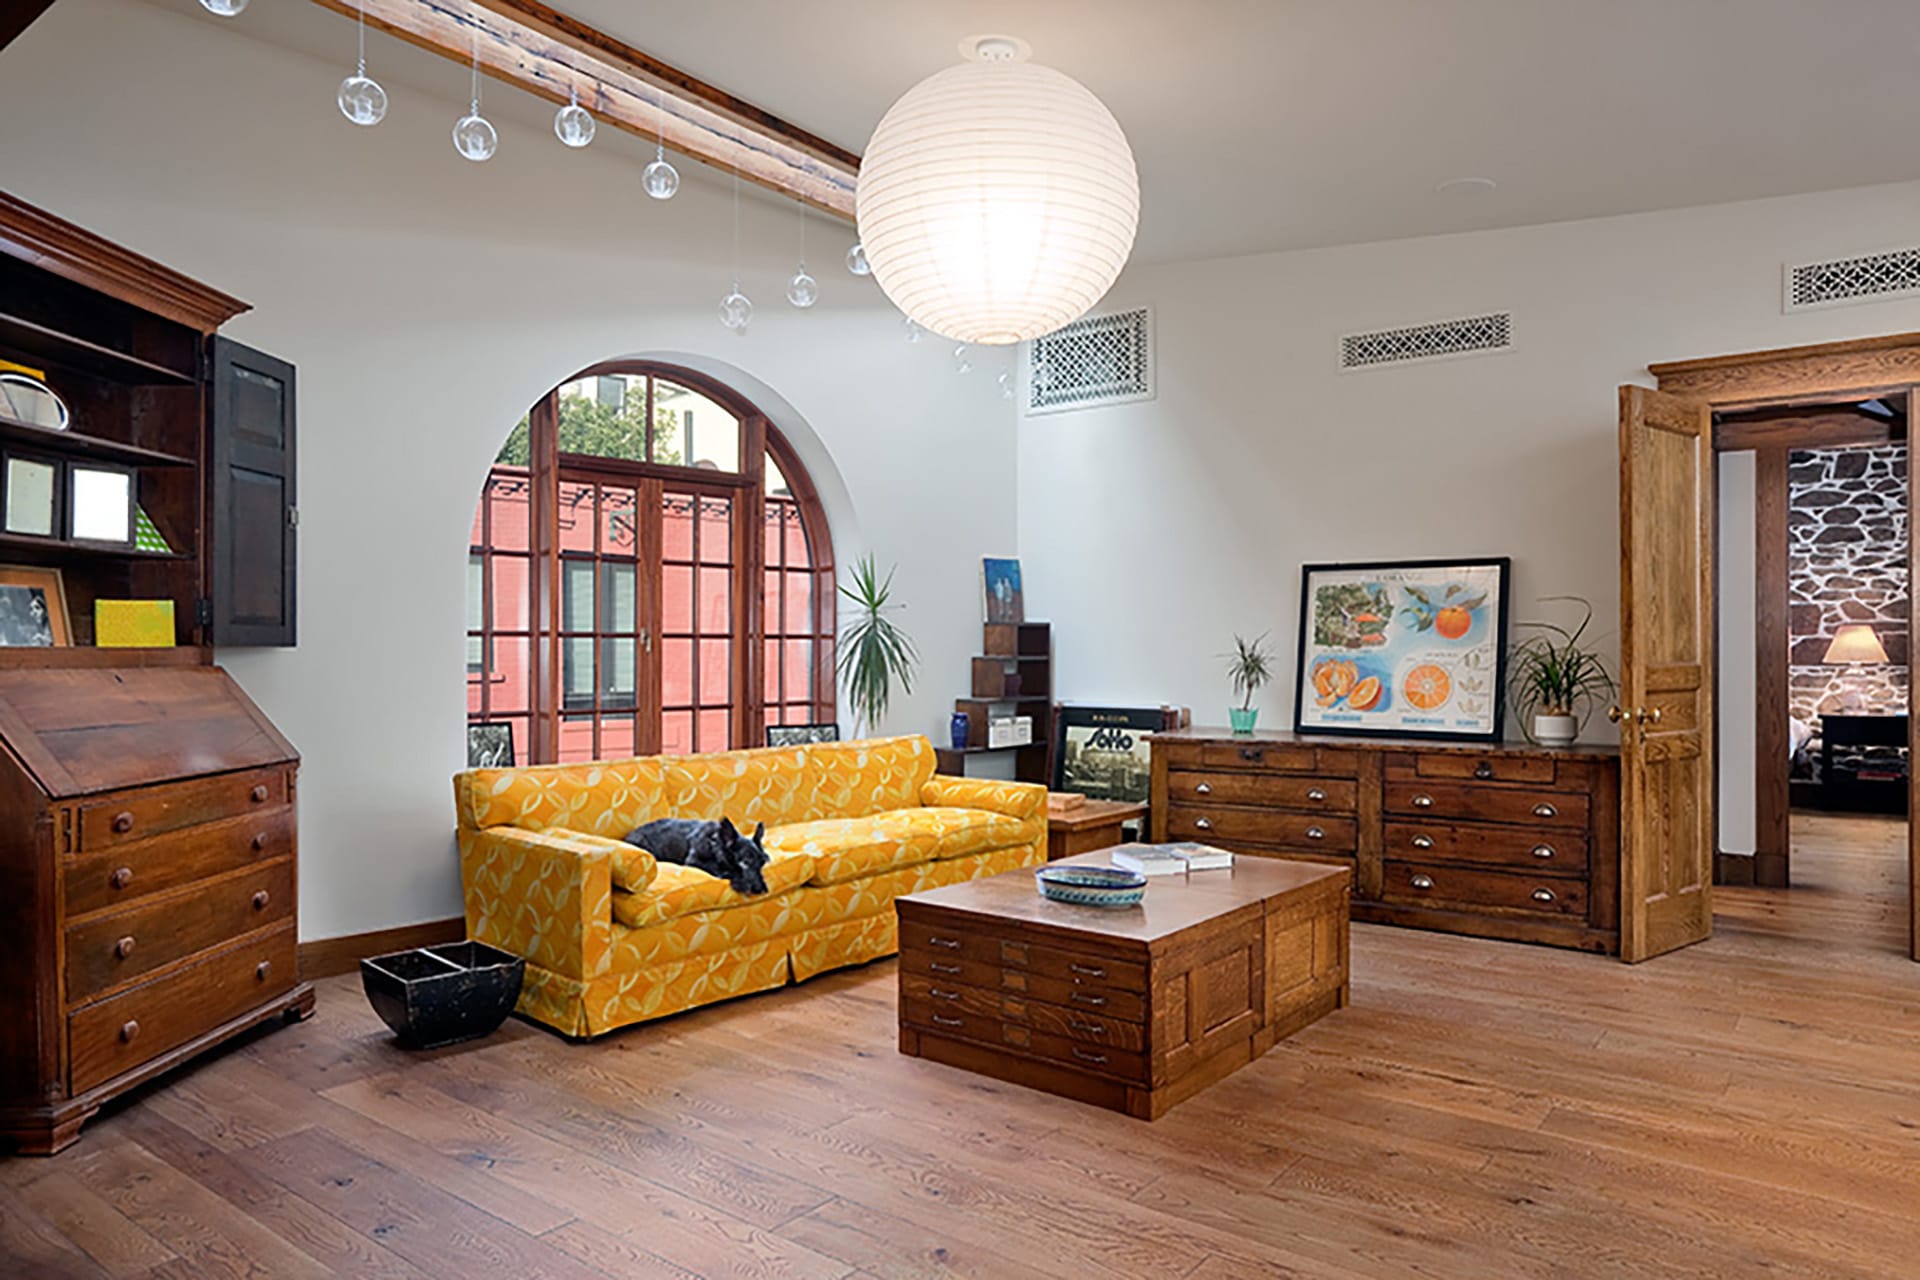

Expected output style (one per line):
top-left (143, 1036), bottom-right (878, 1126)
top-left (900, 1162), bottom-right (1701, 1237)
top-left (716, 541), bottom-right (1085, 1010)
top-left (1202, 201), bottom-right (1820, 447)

top-left (1615, 386), bottom-right (1715, 961)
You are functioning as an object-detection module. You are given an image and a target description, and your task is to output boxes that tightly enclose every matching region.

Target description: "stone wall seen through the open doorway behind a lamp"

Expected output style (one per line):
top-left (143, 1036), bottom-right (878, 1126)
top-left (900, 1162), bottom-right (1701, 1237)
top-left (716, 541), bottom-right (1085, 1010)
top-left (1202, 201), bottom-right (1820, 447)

top-left (1788, 443), bottom-right (1908, 720)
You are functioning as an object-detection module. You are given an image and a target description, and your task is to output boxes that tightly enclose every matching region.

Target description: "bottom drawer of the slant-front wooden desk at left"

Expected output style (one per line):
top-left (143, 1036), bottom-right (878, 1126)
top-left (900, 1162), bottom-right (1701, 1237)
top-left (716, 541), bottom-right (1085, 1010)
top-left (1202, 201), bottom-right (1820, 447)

top-left (67, 925), bottom-right (298, 1094)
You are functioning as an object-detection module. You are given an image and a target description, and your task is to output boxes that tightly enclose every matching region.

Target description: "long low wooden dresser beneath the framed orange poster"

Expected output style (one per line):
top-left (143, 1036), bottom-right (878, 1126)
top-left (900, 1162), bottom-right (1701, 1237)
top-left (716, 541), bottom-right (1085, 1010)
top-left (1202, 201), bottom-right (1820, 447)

top-left (1152, 729), bottom-right (1620, 954)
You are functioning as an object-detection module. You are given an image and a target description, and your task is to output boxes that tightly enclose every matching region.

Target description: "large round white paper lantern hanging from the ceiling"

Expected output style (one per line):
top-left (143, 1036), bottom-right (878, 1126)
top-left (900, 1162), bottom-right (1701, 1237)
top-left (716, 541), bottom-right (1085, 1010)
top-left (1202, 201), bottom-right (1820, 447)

top-left (854, 36), bottom-right (1140, 344)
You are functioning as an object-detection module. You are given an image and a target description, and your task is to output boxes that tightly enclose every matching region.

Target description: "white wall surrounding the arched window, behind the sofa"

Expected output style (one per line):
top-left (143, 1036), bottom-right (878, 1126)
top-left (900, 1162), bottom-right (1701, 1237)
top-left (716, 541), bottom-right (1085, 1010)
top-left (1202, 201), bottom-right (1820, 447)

top-left (0, 0), bottom-right (1016, 936)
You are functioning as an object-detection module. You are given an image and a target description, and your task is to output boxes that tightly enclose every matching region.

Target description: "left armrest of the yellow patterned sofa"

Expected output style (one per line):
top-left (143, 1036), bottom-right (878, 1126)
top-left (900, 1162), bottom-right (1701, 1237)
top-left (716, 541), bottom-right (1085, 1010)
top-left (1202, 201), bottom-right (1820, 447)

top-left (459, 827), bottom-right (634, 979)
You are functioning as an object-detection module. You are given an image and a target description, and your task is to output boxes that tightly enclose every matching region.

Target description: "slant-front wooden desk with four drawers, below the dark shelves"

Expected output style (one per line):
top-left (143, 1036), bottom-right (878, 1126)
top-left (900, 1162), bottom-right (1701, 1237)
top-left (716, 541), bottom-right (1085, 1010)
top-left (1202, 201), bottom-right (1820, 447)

top-left (0, 649), bottom-right (313, 1155)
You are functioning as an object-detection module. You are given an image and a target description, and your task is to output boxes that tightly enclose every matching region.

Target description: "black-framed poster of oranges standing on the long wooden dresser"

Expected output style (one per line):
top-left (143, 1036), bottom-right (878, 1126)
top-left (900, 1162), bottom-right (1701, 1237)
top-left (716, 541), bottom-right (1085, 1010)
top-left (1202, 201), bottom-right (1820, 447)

top-left (1294, 557), bottom-right (1513, 743)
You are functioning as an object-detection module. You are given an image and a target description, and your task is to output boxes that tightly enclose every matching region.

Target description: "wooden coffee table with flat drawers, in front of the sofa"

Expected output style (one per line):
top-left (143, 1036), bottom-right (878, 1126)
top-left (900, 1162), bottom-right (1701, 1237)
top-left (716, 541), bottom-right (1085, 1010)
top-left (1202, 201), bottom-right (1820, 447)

top-left (897, 850), bottom-right (1352, 1121)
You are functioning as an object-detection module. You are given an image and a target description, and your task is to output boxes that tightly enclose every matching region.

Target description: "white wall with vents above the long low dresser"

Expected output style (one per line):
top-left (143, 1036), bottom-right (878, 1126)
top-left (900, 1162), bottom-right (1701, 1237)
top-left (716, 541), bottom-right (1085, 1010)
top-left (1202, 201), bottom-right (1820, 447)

top-left (1020, 184), bottom-right (1920, 760)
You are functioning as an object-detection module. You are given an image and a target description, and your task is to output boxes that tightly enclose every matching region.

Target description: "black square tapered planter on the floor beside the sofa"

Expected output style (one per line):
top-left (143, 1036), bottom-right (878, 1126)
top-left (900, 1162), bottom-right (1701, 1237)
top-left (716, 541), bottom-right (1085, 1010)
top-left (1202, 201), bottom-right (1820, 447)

top-left (361, 942), bottom-right (526, 1050)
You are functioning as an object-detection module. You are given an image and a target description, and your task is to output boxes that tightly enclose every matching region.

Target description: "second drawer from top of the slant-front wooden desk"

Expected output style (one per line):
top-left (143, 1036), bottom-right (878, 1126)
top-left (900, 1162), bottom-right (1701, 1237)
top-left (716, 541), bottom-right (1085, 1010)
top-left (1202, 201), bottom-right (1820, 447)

top-left (65, 808), bottom-right (294, 915)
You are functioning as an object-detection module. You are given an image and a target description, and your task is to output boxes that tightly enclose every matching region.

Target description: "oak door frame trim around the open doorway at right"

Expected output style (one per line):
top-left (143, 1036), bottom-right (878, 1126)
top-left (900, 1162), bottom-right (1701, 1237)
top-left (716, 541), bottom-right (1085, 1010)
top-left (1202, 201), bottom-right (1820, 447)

top-left (1647, 332), bottom-right (1920, 960)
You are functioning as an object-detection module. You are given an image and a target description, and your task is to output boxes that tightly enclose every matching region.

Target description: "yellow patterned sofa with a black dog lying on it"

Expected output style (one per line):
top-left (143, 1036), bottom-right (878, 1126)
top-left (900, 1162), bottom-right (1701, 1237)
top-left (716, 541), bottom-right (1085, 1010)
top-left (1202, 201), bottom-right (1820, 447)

top-left (453, 737), bottom-right (1046, 1036)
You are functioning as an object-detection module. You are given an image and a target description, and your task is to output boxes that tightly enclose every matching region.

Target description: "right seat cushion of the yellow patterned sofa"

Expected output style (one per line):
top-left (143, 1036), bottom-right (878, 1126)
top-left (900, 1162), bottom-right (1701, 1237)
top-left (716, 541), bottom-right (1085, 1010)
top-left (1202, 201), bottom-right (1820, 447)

top-left (766, 808), bottom-right (1033, 885)
